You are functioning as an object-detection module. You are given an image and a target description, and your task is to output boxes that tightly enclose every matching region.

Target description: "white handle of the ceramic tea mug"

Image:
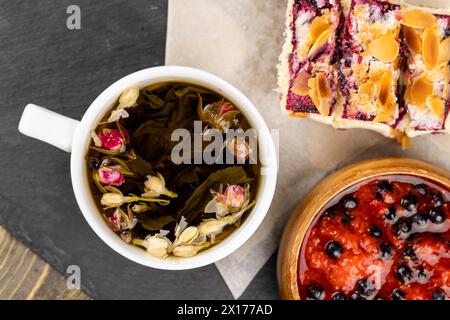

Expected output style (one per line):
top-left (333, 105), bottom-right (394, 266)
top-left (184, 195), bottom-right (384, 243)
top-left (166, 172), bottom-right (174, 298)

top-left (19, 104), bottom-right (80, 152)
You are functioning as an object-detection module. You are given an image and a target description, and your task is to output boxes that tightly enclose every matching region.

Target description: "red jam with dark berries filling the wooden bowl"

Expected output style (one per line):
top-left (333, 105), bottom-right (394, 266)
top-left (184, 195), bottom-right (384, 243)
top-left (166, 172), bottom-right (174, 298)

top-left (298, 176), bottom-right (450, 300)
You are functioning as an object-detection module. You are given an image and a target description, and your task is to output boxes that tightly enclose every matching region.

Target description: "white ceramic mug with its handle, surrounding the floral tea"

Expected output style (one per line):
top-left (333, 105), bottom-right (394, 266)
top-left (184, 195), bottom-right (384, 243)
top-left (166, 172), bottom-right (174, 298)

top-left (19, 66), bottom-right (277, 270)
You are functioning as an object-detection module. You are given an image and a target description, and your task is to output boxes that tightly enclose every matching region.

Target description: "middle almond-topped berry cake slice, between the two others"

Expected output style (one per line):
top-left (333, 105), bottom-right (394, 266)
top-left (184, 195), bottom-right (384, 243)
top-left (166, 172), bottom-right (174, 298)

top-left (334, 0), bottom-right (404, 137)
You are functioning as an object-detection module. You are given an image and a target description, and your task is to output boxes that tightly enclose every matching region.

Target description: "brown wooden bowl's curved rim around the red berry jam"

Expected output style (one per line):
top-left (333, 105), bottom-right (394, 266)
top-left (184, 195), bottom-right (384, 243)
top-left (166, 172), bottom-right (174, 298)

top-left (277, 158), bottom-right (450, 300)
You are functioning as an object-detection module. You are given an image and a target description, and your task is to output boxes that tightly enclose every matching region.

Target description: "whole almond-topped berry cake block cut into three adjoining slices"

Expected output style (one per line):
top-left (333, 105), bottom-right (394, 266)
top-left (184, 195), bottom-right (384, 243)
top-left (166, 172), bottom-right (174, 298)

top-left (278, 0), bottom-right (450, 145)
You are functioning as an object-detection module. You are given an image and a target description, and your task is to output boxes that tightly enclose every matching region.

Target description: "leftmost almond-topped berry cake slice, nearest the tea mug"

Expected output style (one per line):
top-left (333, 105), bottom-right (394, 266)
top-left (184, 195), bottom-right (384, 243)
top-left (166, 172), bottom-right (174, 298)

top-left (278, 0), bottom-right (342, 123)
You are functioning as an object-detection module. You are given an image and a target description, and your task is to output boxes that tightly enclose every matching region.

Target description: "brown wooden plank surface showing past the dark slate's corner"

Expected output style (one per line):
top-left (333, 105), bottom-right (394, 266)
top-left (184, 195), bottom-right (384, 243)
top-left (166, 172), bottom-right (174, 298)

top-left (0, 227), bottom-right (90, 300)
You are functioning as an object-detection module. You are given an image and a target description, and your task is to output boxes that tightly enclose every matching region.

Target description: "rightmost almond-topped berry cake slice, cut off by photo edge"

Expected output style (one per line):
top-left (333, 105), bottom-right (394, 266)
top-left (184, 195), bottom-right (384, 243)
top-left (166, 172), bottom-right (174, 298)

top-left (401, 5), bottom-right (450, 137)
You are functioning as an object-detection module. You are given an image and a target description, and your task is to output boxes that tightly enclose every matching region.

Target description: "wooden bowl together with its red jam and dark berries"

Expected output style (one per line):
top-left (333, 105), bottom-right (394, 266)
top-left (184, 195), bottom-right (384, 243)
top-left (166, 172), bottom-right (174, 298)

top-left (278, 158), bottom-right (450, 300)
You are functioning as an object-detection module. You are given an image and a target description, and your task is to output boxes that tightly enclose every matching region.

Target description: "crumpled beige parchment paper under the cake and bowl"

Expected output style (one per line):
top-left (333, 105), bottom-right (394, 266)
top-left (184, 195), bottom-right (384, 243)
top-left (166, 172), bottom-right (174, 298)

top-left (166, 0), bottom-right (450, 298)
